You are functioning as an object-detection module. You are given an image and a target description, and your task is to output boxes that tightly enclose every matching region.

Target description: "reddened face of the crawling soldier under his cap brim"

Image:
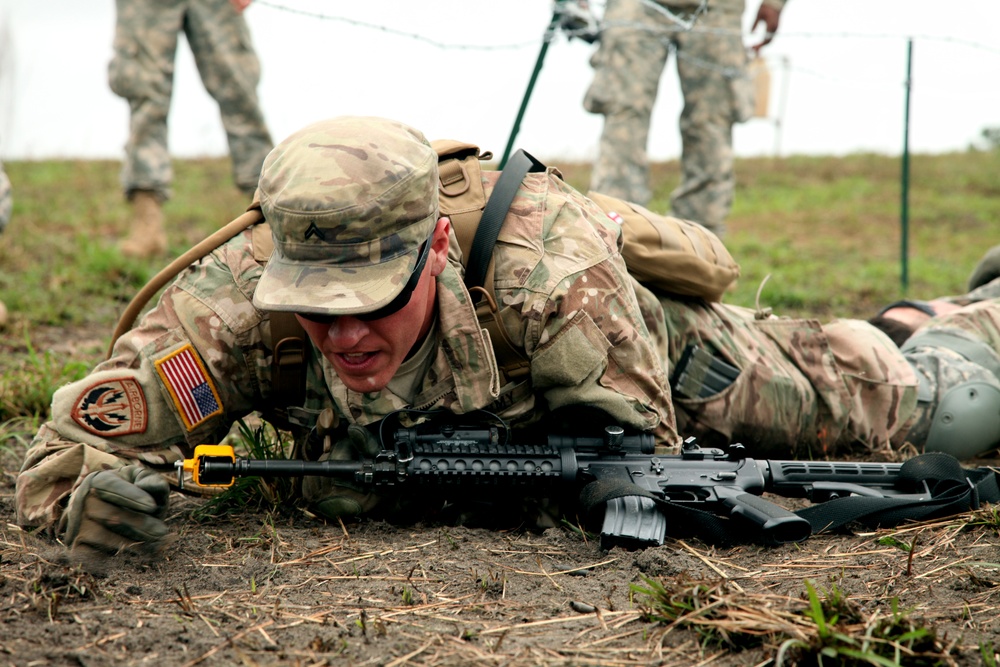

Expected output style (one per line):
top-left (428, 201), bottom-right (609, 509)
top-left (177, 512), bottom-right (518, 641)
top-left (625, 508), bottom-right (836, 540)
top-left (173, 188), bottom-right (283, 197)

top-left (296, 218), bottom-right (449, 392)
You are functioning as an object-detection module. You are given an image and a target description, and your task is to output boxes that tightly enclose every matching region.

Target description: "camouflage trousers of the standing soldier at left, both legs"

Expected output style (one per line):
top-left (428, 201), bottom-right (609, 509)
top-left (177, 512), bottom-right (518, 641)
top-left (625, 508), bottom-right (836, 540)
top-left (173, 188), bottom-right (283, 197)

top-left (108, 0), bottom-right (272, 201)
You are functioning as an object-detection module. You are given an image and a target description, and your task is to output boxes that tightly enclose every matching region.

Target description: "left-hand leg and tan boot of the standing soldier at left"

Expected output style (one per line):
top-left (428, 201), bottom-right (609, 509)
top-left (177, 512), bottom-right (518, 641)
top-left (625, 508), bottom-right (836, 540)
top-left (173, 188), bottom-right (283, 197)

top-left (108, 0), bottom-right (184, 257)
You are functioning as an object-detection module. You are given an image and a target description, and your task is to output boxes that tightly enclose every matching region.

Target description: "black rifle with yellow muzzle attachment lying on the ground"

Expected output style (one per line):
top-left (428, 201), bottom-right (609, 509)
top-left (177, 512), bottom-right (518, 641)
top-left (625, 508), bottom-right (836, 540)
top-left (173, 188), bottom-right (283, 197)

top-left (175, 422), bottom-right (1000, 549)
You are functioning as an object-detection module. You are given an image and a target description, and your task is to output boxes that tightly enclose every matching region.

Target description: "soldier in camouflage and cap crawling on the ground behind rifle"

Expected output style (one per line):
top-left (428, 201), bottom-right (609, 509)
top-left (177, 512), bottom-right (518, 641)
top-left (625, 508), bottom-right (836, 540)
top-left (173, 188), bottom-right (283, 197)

top-left (16, 117), bottom-right (1000, 554)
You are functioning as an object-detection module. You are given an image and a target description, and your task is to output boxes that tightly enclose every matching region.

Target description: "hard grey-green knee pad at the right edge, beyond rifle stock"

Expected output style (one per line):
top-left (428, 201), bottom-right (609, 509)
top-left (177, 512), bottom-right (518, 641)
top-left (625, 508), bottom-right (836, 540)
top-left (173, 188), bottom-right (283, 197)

top-left (924, 382), bottom-right (1000, 459)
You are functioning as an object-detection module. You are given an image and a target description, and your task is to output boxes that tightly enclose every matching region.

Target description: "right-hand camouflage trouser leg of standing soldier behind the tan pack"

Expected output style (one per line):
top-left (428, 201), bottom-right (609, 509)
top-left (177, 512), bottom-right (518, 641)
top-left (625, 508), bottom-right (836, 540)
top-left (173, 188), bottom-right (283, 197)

top-left (671, 8), bottom-right (753, 236)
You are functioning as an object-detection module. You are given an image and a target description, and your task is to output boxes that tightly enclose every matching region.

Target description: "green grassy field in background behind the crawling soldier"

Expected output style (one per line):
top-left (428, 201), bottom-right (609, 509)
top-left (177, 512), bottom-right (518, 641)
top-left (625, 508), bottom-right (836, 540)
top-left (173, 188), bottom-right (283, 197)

top-left (0, 151), bottom-right (1000, 423)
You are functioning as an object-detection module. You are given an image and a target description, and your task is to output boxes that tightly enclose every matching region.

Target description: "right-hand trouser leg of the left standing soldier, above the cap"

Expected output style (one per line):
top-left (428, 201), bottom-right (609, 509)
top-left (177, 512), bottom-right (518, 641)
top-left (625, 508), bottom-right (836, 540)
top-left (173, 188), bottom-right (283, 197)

top-left (184, 0), bottom-right (274, 196)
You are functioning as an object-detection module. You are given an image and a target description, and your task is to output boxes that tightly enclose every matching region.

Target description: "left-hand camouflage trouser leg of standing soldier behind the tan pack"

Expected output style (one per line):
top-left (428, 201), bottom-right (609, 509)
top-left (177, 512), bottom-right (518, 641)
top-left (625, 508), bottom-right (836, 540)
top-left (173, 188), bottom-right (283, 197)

top-left (583, 0), bottom-right (670, 204)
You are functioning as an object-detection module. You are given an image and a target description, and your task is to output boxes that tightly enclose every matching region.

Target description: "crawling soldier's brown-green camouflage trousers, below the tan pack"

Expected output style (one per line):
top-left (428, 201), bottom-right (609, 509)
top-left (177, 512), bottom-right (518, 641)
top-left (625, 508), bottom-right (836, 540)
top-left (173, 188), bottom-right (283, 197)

top-left (644, 295), bottom-right (917, 458)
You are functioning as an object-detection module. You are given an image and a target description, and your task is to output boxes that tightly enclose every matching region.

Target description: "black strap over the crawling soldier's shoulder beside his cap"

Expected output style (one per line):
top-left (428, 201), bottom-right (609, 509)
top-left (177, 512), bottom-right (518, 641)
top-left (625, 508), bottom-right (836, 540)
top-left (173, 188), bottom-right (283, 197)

top-left (465, 149), bottom-right (545, 300)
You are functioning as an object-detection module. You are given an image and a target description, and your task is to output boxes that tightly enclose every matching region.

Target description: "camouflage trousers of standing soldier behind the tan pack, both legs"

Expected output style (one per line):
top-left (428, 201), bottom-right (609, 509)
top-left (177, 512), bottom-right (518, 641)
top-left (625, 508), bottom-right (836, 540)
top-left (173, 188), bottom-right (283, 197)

top-left (584, 0), bottom-right (784, 235)
